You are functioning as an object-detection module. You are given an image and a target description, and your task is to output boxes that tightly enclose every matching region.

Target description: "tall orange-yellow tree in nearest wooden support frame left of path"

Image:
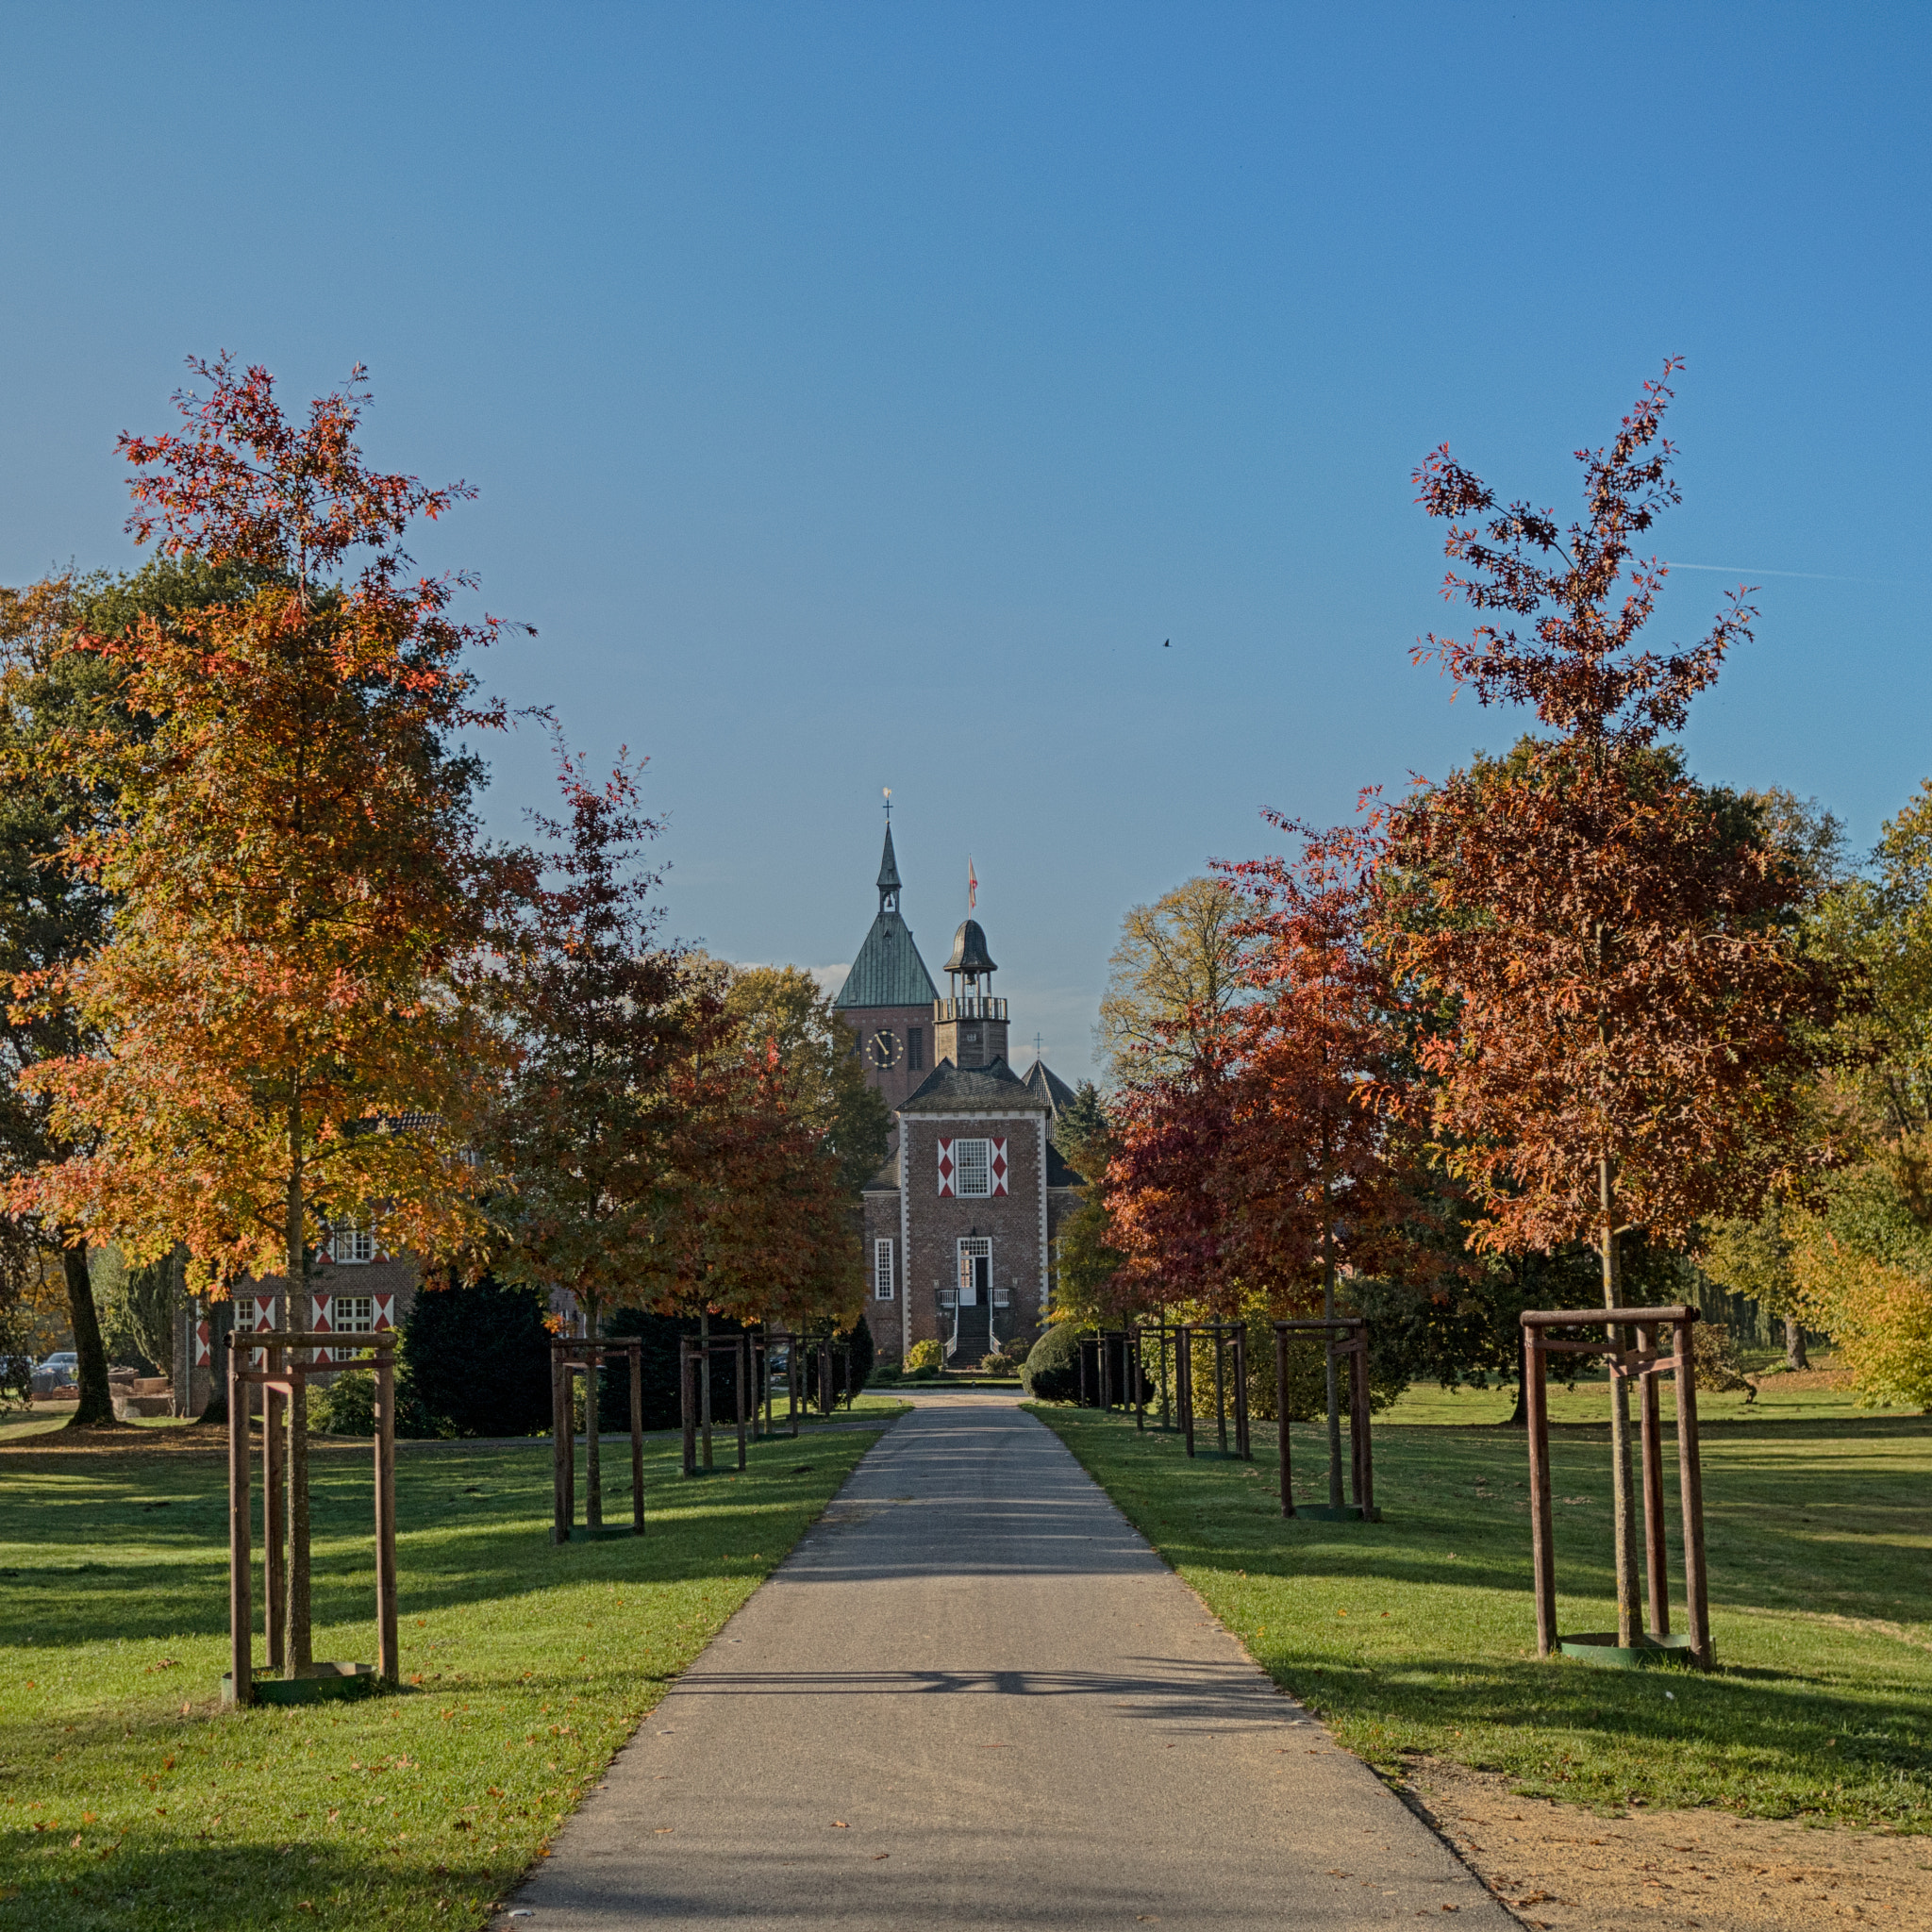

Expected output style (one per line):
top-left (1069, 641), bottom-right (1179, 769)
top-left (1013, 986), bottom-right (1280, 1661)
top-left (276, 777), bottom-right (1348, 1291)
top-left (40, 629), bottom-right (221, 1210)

top-left (9, 358), bottom-right (498, 1674)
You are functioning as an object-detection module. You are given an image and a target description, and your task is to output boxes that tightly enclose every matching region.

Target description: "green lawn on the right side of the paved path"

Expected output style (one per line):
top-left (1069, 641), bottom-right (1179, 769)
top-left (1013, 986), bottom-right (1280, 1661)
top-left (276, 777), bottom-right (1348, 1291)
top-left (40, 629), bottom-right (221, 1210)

top-left (1036, 1385), bottom-right (1932, 1832)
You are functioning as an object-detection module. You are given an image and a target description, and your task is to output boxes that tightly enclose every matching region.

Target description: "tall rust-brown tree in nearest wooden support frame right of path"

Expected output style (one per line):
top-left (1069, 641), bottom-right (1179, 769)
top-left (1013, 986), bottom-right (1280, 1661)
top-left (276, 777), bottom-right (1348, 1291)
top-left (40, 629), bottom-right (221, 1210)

top-left (1381, 363), bottom-right (1829, 1644)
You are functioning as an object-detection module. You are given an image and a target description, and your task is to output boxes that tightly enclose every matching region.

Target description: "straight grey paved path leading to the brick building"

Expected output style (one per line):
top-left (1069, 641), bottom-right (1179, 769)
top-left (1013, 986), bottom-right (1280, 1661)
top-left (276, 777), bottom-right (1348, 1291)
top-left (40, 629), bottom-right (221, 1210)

top-left (500, 1395), bottom-right (1511, 1932)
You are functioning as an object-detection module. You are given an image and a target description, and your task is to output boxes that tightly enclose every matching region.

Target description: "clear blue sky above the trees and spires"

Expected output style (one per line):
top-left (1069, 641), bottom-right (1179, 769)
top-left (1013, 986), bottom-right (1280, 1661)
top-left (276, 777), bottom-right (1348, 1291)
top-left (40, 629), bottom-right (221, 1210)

top-left (0, 0), bottom-right (1932, 1074)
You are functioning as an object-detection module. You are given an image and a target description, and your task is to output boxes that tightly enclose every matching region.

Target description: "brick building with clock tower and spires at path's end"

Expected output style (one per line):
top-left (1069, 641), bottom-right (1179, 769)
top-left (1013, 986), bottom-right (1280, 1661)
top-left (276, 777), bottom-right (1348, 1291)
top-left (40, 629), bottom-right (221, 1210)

top-left (837, 827), bottom-right (1082, 1368)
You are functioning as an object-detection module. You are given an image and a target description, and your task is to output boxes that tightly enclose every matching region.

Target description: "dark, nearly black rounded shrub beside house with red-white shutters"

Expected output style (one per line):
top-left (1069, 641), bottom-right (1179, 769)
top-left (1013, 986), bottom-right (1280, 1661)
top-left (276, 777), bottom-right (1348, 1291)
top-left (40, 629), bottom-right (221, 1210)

top-left (404, 1277), bottom-right (551, 1436)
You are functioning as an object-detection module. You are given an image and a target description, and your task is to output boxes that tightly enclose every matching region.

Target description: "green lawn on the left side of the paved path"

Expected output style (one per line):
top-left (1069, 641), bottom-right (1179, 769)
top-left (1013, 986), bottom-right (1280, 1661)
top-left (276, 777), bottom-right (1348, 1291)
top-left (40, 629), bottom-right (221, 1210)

top-left (0, 1405), bottom-right (896, 1932)
